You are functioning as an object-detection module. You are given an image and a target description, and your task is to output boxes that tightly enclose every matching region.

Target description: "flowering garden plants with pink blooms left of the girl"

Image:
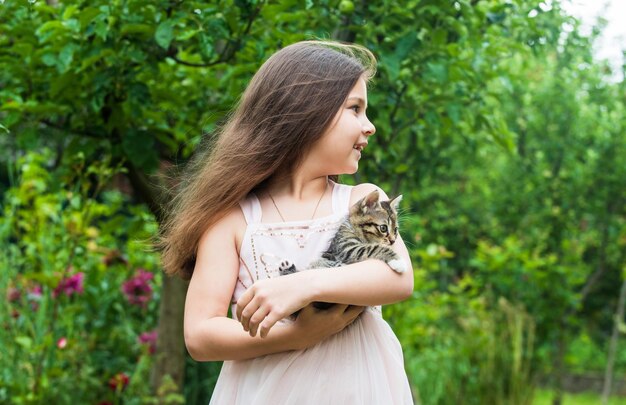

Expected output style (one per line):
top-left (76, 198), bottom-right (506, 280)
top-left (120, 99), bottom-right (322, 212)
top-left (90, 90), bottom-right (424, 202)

top-left (0, 150), bottom-right (158, 404)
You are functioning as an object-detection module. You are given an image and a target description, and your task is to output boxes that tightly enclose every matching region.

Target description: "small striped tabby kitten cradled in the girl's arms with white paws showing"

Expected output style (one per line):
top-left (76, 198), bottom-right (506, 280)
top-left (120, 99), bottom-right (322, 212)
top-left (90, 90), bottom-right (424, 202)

top-left (279, 190), bottom-right (407, 309)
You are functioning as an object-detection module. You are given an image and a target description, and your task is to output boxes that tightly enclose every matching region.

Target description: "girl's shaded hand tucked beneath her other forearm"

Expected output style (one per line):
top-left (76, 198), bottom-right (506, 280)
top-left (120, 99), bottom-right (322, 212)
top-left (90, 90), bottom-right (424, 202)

top-left (291, 304), bottom-right (365, 350)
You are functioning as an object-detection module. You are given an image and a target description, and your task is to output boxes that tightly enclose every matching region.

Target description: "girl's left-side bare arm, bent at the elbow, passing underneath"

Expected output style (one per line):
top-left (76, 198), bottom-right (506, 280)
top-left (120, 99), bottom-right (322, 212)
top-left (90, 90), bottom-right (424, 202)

top-left (184, 208), bottom-right (363, 361)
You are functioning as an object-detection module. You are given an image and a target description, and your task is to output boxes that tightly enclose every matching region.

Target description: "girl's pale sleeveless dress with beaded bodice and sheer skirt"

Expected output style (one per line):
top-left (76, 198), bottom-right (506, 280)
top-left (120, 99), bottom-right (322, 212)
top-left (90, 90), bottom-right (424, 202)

top-left (210, 183), bottom-right (413, 405)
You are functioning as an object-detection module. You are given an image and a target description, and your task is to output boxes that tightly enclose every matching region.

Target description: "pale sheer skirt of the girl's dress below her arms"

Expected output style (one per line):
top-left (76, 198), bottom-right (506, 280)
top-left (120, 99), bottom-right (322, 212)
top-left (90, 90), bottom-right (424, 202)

top-left (210, 308), bottom-right (413, 405)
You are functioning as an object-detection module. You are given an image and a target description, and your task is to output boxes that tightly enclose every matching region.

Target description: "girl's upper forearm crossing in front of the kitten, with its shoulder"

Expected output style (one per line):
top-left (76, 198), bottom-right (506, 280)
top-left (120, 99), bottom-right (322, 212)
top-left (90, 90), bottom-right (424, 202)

top-left (237, 184), bottom-right (413, 337)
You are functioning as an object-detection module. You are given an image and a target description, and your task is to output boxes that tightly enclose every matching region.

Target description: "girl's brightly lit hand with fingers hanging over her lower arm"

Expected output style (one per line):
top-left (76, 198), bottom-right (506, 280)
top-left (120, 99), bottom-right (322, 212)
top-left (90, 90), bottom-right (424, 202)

top-left (237, 273), bottom-right (311, 337)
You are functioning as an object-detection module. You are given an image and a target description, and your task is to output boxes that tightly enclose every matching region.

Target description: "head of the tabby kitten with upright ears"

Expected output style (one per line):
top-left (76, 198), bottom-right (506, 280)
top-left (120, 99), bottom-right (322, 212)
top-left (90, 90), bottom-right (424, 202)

top-left (348, 190), bottom-right (402, 245)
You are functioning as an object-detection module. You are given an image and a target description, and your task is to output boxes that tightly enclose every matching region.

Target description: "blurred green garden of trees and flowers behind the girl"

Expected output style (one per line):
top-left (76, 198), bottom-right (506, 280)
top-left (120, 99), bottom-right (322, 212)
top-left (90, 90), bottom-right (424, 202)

top-left (0, 0), bottom-right (626, 405)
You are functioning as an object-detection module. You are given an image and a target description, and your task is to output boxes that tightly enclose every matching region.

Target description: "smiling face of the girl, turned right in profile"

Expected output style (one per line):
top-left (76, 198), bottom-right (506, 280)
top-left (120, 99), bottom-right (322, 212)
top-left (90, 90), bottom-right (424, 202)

top-left (307, 78), bottom-right (376, 175)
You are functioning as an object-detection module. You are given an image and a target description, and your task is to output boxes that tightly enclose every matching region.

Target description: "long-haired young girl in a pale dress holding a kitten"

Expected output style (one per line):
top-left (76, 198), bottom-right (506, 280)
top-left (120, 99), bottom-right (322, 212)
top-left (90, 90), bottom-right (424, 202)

top-left (163, 41), bottom-right (413, 405)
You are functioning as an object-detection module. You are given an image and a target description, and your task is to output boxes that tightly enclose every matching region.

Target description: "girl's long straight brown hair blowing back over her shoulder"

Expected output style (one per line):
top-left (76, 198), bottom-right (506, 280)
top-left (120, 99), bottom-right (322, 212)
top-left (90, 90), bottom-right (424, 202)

top-left (159, 41), bottom-right (376, 278)
